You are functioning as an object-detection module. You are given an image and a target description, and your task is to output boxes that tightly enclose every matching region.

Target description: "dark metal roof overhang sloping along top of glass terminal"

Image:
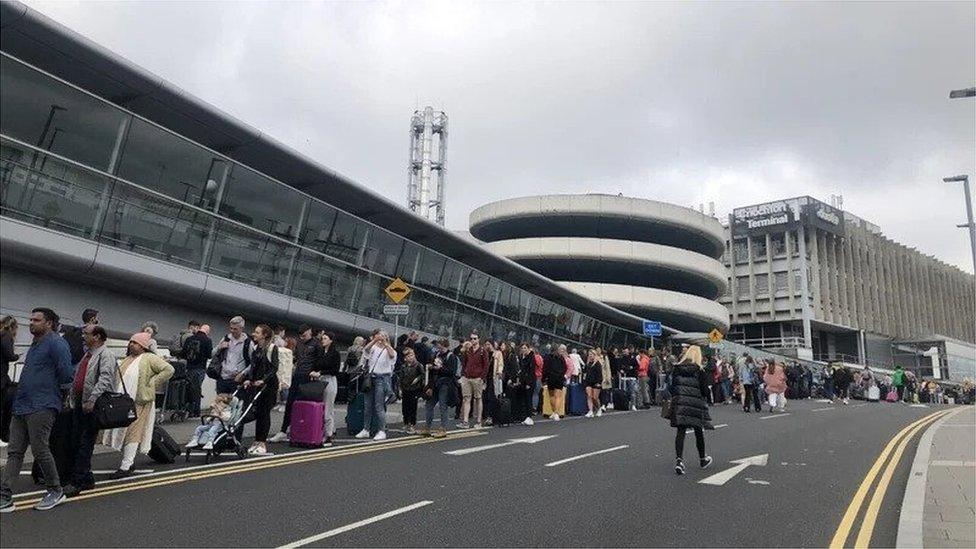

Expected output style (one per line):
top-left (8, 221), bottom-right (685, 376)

top-left (0, 0), bottom-right (641, 333)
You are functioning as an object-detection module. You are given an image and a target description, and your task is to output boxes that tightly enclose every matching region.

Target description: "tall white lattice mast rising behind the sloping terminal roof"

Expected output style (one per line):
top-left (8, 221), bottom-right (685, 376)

top-left (407, 107), bottom-right (447, 226)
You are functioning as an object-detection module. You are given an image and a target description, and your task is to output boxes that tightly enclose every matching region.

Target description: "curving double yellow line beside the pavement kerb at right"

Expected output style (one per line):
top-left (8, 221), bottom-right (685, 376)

top-left (830, 410), bottom-right (952, 549)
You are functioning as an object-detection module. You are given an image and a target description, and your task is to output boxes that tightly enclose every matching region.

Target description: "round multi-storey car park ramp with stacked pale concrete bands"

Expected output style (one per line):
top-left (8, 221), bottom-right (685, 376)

top-left (470, 194), bottom-right (729, 332)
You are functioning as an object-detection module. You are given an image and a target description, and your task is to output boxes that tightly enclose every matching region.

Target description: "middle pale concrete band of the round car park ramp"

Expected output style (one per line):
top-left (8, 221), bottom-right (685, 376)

top-left (485, 236), bottom-right (728, 296)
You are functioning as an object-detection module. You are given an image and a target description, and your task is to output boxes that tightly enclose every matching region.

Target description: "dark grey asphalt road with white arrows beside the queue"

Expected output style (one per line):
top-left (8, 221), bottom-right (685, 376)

top-left (0, 401), bottom-right (941, 547)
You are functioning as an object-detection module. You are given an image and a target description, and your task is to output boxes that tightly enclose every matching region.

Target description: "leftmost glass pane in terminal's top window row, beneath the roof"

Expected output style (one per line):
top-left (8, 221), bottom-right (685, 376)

top-left (0, 57), bottom-right (128, 171)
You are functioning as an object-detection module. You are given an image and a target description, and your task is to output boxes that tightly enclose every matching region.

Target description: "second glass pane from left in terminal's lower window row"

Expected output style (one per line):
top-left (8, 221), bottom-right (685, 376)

top-left (99, 183), bottom-right (212, 269)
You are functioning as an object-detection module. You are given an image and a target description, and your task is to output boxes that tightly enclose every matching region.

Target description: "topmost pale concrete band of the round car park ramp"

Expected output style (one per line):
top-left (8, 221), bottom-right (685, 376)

top-left (468, 194), bottom-right (725, 258)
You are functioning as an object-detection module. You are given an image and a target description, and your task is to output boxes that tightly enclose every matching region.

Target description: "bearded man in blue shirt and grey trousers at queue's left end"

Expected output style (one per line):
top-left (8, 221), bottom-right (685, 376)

top-left (0, 307), bottom-right (74, 513)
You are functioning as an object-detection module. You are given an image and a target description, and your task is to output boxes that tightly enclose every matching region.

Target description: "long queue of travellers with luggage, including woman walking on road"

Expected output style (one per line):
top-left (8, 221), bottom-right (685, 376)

top-left (0, 307), bottom-right (972, 512)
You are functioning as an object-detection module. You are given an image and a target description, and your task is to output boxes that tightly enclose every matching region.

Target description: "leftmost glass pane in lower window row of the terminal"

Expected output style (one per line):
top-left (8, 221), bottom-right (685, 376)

top-left (0, 140), bottom-right (110, 236)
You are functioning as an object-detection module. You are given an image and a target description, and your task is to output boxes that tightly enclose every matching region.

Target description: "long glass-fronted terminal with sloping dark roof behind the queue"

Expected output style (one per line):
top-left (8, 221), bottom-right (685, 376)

top-left (0, 2), bottom-right (656, 346)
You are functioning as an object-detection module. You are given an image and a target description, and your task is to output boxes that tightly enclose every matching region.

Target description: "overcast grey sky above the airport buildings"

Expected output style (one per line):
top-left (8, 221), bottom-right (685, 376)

top-left (22, 1), bottom-right (976, 272)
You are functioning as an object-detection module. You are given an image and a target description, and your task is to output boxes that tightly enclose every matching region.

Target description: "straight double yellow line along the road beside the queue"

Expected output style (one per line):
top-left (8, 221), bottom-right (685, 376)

top-left (14, 431), bottom-right (485, 511)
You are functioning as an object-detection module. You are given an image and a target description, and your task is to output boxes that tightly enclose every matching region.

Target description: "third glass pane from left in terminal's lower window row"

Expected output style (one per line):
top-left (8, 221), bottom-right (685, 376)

top-left (207, 222), bottom-right (296, 293)
